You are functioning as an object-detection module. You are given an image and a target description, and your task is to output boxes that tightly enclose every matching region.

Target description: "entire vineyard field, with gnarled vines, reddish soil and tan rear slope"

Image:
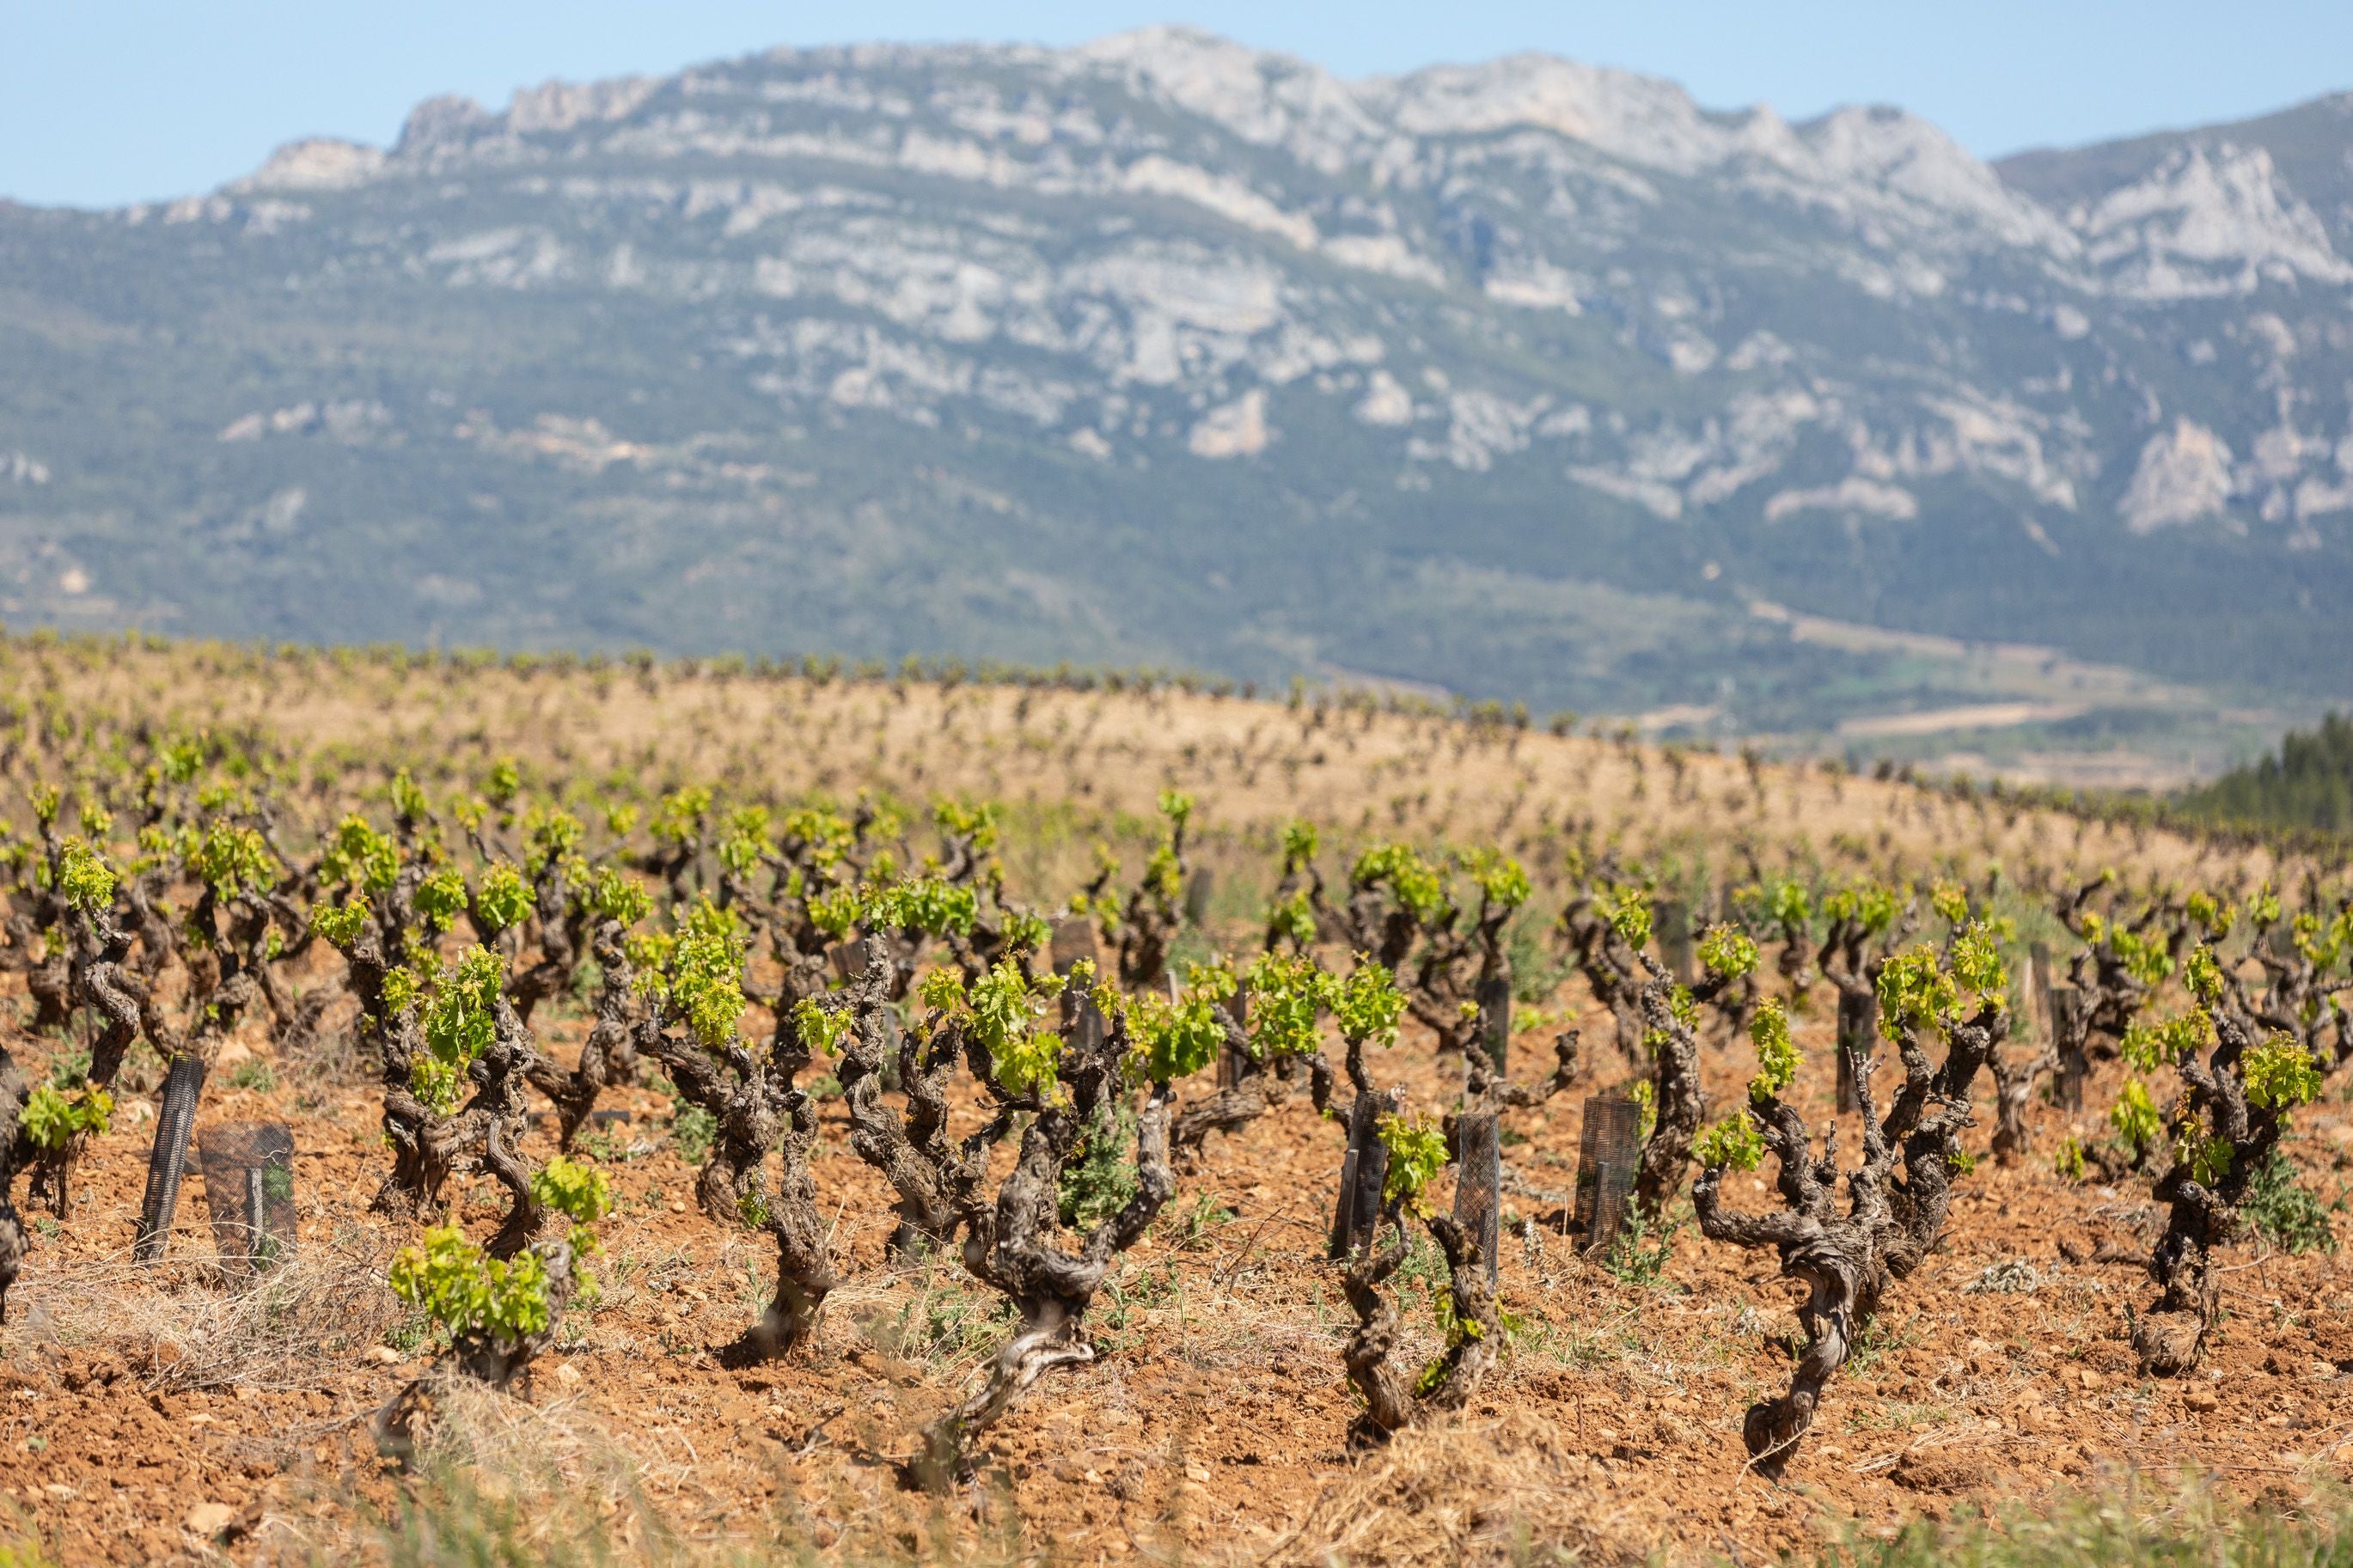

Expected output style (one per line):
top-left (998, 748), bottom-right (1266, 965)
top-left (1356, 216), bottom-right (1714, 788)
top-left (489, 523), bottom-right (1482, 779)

top-left (0, 635), bottom-right (2353, 1564)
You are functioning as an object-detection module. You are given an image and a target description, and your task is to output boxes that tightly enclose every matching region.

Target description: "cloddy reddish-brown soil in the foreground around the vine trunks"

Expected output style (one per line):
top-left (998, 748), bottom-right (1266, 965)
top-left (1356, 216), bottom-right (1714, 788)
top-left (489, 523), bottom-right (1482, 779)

top-left (0, 973), bottom-right (2353, 1564)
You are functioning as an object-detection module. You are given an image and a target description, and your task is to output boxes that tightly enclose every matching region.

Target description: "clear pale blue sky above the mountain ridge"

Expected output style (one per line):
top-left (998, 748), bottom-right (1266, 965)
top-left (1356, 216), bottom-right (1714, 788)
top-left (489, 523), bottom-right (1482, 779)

top-left (0, 0), bottom-right (2353, 207)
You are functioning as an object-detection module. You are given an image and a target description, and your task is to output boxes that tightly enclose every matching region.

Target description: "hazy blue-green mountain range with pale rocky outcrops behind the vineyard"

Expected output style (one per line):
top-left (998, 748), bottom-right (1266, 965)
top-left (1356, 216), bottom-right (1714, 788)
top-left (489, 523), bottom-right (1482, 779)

top-left (0, 31), bottom-right (2353, 771)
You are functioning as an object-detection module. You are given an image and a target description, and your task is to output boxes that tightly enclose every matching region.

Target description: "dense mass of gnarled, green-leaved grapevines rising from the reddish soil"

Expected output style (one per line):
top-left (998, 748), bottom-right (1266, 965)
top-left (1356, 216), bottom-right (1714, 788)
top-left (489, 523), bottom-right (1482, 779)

top-left (0, 710), bottom-right (2353, 1486)
